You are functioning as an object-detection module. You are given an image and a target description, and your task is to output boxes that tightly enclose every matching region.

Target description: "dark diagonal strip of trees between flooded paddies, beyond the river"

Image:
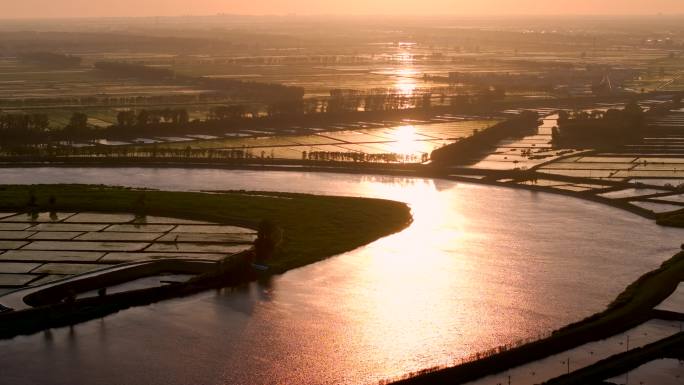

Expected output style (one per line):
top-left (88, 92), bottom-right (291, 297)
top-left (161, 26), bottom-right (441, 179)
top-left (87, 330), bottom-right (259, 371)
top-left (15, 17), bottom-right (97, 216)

top-left (430, 111), bottom-right (539, 165)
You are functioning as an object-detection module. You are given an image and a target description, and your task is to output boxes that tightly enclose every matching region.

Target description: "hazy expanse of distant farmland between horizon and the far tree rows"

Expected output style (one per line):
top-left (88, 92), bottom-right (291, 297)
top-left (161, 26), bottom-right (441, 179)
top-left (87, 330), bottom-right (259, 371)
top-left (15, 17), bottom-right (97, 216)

top-left (0, 16), bottom-right (684, 132)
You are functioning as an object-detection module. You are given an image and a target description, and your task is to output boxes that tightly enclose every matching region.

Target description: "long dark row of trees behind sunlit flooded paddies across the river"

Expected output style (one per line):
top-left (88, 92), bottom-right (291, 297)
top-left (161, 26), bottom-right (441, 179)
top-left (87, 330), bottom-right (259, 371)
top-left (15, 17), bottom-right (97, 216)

top-left (0, 90), bottom-right (510, 146)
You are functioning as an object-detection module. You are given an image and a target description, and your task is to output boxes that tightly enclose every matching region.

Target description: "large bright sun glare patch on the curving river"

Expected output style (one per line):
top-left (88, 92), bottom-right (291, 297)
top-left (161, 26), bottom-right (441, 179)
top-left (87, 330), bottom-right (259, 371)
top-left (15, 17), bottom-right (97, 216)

top-left (343, 178), bottom-right (486, 374)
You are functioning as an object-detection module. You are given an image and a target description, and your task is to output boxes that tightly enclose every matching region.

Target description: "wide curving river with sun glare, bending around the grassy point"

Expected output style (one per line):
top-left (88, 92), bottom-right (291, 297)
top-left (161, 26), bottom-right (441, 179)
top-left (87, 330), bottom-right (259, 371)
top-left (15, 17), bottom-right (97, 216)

top-left (0, 168), bottom-right (684, 384)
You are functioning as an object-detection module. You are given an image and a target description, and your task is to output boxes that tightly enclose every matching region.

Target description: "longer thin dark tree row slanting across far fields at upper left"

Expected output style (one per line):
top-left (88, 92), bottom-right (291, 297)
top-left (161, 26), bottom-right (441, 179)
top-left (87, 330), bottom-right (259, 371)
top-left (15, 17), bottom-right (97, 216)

top-left (95, 61), bottom-right (304, 102)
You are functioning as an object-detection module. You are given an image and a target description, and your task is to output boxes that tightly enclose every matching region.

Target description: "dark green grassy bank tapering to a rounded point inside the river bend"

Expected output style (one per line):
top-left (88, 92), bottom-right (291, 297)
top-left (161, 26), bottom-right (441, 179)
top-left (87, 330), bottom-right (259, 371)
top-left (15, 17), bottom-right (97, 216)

top-left (0, 185), bottom-right (411, 272)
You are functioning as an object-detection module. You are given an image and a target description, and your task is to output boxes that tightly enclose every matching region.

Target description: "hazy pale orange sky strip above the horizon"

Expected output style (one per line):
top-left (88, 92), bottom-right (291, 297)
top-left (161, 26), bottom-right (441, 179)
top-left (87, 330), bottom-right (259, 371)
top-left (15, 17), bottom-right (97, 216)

top-left (0, 0), bottom-right (684, 18)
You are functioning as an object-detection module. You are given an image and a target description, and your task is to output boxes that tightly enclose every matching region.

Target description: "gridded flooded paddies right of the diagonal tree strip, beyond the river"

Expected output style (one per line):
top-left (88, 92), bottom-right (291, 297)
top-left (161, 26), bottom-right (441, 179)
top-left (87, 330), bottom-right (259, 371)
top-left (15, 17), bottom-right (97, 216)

top-left (422, 106), bottom-right (684, 218)
